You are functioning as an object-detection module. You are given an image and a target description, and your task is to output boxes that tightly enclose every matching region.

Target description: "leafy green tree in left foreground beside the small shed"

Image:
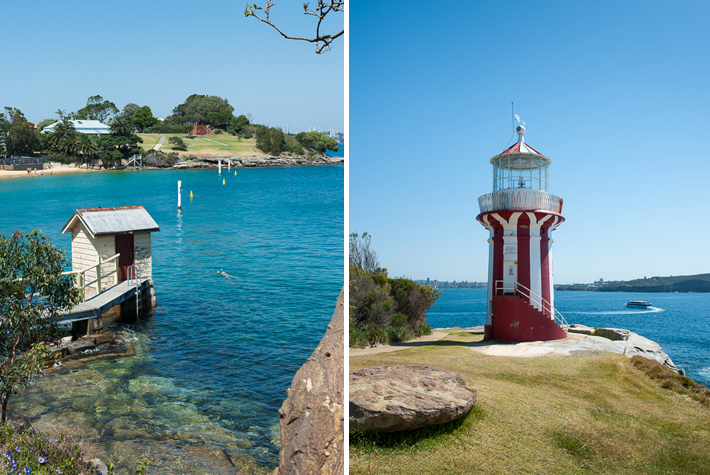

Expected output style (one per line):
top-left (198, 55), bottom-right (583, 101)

top-left (0, 229), bottom-right (80, 425)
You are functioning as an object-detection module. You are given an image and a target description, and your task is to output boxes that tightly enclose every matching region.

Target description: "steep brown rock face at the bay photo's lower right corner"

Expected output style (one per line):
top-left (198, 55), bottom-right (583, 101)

top-left (274, 291), bottom-right (345, 475)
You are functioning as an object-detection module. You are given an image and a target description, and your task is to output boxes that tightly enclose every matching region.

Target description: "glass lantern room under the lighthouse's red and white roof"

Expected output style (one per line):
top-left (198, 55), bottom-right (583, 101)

top-left (492, 154), bottom-right (550, 192)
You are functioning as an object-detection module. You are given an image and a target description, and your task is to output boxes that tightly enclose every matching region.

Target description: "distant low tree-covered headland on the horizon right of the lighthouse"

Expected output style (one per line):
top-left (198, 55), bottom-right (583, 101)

top-left (555, 274), bottom-right (710, 292)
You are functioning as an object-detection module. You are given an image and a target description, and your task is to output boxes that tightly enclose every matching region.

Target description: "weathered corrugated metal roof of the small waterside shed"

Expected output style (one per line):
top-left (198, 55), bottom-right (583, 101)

top-left (62, 206), bottom-right (160, 236)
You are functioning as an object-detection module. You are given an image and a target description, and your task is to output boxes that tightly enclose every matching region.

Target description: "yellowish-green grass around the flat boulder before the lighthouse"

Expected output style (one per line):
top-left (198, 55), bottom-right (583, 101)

top-left (349, 332), bottom-right (710, 475)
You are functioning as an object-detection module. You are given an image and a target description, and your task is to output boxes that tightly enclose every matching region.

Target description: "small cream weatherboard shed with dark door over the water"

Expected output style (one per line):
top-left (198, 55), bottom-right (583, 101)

top-left (62, 206), bottom-right (160, 296)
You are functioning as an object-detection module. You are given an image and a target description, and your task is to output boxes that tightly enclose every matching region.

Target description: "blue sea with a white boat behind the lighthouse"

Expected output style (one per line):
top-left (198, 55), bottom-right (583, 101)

top-left (427, 289), bottom-right (710, 387)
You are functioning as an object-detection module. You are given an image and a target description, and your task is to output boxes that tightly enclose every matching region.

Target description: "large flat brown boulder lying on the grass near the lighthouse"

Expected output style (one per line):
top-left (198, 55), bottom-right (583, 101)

top-left (350, 365), bottom-right (476, 432)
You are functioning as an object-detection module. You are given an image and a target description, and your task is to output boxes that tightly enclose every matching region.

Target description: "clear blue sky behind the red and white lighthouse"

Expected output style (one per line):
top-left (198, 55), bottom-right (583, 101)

top-left (349, 0), bottom-right (710, 283)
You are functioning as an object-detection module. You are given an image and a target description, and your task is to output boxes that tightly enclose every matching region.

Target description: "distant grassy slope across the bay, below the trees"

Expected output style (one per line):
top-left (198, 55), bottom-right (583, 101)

top-left (138, 134), bottom-right (264, 158)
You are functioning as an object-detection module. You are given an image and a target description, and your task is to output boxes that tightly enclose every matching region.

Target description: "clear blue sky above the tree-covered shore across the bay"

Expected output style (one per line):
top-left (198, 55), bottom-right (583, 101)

top-left (0, 0), bottom-right (344, 132)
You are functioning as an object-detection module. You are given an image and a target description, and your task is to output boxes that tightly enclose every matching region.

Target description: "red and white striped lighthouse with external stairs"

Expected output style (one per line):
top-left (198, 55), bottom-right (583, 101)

top-left (476, 125), bottom-right (567, 342)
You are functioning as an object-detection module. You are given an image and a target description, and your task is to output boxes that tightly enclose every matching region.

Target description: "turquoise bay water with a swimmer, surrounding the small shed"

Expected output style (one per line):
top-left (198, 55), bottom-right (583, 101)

top-left (0, 165), bottom-right (344, 474)
